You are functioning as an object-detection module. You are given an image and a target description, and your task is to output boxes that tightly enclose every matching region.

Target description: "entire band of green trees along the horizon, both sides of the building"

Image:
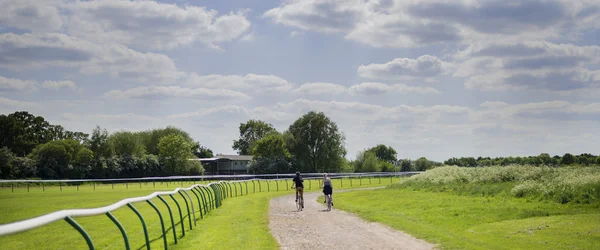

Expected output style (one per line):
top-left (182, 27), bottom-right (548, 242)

top-left (0, 111), bottom-right (600, 179)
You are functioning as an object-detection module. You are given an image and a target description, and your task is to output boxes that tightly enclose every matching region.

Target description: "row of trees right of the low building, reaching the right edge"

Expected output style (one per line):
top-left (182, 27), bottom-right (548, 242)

top-left (232, 111), bottom-right (600, 174)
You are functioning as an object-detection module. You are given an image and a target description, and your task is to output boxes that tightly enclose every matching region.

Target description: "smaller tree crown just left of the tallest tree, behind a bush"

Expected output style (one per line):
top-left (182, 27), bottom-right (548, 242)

top-left (232, 120), bottom-right (276, 155)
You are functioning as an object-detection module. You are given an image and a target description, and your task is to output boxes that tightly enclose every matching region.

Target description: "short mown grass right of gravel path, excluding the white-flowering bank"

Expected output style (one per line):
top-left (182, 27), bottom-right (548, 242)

top-left (335, 183), bottom-right (600, 249)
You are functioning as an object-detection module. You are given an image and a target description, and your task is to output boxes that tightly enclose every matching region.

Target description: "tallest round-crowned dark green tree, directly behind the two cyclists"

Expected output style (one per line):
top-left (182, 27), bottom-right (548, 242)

top-left (286, 111), bottom-right (346, 172)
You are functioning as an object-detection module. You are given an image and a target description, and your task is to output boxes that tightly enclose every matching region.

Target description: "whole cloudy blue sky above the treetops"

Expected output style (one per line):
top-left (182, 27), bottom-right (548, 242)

top-left (0, 0), bottom-right (600, 161)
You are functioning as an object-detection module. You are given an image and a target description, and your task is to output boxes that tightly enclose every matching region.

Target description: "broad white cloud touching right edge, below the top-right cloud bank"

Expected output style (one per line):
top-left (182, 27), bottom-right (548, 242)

top-left (454, 41), bottom-right (600, 94)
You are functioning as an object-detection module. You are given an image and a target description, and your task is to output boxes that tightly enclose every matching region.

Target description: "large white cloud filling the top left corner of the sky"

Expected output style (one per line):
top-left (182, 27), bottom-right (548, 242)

top-left (0, 0), bottom-right (250, 50)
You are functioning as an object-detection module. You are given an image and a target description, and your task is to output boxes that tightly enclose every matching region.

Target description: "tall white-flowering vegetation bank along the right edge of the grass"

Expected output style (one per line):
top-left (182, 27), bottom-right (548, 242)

top-left (400, 165), bottom-right (600, 203)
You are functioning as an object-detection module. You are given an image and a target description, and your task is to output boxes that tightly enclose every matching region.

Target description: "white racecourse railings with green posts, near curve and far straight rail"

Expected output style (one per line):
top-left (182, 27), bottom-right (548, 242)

top-left (0, 172), bottom-right (420, 250)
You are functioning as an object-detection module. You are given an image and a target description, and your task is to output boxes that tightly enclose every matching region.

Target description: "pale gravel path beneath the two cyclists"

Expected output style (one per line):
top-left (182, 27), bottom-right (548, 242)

top-left (269, 188), bottom-right (434, 250)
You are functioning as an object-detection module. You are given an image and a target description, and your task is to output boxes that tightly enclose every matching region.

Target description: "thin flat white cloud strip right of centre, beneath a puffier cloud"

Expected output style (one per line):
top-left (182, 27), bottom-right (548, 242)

top-left (349, 82), bottom-right (441, 95)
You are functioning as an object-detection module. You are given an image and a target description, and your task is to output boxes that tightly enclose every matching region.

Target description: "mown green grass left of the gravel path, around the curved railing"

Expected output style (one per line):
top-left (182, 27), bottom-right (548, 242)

top-left (0, 178), bottom-right (399, 249)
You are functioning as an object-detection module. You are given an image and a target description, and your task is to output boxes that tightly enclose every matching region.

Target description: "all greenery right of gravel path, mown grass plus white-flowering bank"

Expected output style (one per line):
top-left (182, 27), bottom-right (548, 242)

top-left (335, 166), bottom-right (600, 249)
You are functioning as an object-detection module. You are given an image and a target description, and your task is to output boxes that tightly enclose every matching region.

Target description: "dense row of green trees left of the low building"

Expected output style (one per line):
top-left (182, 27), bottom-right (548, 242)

top-left (0, 111), bottom-right (213, 179)
